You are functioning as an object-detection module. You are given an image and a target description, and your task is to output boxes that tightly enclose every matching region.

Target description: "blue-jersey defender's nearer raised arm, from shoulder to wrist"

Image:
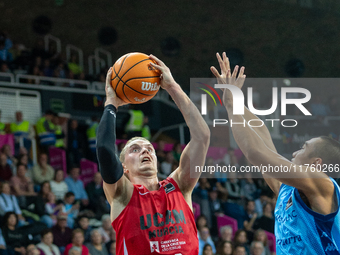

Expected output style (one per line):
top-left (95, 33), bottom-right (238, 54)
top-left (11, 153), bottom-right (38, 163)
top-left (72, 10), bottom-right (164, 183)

top-left (212, 56), bottom-right (334, 213)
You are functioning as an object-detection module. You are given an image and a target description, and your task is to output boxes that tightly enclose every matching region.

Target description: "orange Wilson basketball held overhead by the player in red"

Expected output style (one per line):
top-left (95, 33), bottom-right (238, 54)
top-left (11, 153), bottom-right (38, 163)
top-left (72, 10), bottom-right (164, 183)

top-left (111, 52), bottom-right (160, 104)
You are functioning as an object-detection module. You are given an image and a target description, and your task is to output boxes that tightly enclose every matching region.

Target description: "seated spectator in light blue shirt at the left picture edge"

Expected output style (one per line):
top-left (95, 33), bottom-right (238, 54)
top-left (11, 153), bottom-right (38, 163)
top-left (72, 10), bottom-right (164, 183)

top-left (0, 182), bottom-right (25, 222)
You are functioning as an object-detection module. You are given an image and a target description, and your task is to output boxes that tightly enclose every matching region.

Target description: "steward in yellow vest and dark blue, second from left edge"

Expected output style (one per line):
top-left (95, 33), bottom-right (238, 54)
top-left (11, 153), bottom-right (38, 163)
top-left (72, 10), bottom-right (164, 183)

top-left (36, 110), bottom-right (56, 153)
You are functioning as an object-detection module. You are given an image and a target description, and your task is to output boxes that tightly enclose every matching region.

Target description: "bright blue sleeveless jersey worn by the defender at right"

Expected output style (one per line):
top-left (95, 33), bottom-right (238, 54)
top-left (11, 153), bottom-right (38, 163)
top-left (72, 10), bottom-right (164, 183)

top-left (275, 178), bottom-right (340, 255)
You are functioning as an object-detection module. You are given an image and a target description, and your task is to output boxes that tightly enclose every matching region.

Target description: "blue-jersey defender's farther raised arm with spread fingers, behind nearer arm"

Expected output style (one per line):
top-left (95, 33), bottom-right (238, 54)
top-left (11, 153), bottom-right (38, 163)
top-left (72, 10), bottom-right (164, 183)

top-left (211, 52), bottom-right (281, 195)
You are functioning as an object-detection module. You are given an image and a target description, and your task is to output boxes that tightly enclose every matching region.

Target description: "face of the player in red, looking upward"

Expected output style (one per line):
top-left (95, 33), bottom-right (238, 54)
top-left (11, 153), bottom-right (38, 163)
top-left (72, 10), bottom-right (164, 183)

top-left (124, 140), bottom-right (157, 175)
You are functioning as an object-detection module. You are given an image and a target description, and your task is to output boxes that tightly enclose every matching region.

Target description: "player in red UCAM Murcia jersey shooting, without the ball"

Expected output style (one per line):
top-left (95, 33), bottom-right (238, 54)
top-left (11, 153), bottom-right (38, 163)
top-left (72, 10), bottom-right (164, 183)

top-left (97, 55), bottom-right (210, 255)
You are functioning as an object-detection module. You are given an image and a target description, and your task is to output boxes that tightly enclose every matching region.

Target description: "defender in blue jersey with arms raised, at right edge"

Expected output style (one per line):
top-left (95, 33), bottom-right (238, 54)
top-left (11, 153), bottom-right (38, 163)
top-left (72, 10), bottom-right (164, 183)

top-left (211, 53), bottom-right (340, 255)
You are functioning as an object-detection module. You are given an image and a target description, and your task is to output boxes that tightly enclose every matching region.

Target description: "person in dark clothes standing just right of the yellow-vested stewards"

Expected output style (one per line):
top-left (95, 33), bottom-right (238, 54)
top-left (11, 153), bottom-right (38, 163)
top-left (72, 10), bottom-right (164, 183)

top-left (67, 120), bottom-right (84, 165)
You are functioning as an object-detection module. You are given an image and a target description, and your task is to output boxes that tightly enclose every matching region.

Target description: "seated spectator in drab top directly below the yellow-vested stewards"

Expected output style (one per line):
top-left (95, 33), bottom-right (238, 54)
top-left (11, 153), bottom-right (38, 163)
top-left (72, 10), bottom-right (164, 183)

top-left (32, 153), bottom-right (54, 184)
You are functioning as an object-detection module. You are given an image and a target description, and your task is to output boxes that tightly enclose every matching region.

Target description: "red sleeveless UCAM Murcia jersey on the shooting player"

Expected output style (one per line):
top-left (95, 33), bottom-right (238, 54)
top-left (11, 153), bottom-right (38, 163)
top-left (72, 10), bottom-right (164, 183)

top-left (112, 177), bottom-right (198, 255)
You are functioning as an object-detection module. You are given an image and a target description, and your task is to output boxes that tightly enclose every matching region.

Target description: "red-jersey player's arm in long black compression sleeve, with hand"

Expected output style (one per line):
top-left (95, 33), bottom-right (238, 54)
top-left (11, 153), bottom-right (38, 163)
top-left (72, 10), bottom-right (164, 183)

top-left (97, 68), bottom-right (133, 204)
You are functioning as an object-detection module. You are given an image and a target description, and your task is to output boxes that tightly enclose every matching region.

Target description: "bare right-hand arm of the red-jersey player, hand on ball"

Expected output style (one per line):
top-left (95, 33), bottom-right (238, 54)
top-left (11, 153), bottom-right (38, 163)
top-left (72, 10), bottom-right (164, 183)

top-left (150, 55), bottom-right (210, 197)
